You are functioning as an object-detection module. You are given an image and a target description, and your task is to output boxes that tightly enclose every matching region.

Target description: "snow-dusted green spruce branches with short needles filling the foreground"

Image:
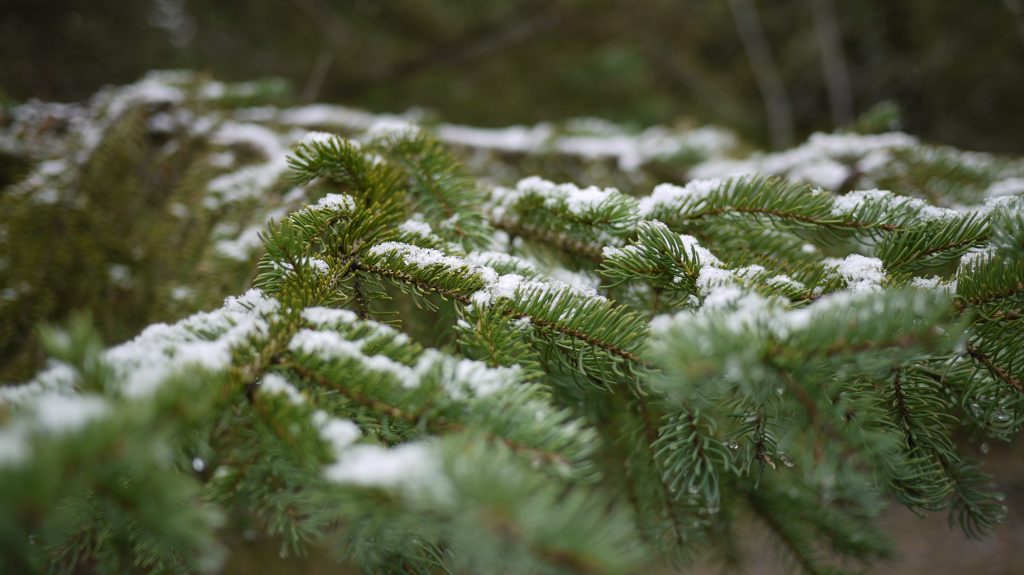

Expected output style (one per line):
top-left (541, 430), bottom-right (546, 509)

top-left (0, 73), bottom-right (1024, 574)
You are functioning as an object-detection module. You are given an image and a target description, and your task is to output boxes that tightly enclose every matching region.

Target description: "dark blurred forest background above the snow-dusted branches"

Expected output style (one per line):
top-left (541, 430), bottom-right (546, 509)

top-left (6, 0), bottom-right (1024, 152)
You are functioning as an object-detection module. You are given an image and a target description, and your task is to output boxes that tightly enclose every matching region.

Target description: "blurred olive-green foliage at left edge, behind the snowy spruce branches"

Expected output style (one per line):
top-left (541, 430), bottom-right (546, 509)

top-left (0, 107), bottom-right (250, 381)
